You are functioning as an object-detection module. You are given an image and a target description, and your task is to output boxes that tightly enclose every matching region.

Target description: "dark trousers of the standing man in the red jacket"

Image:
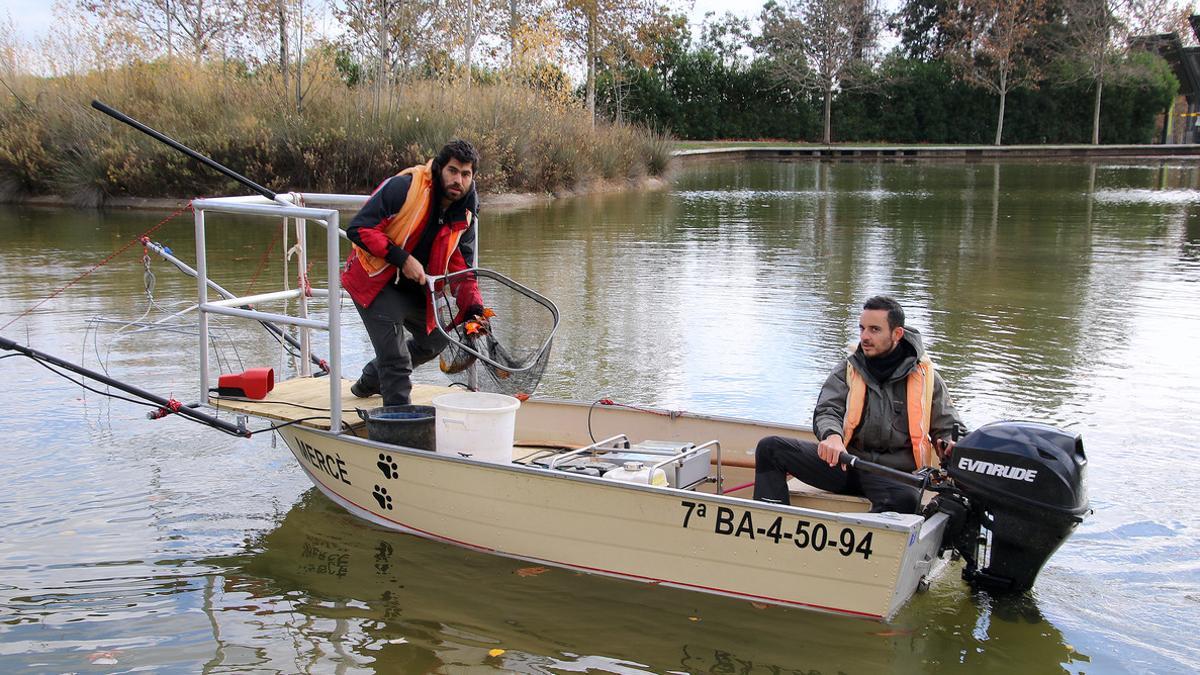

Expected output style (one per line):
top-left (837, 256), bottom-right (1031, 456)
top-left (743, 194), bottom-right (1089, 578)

top-left (354, 283), bottom-right (446, 406)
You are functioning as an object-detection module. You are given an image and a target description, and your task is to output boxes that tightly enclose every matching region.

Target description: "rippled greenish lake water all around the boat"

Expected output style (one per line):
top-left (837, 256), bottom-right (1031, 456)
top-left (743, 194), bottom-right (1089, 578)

top-left (0, 160), bottom-right (1200, 674)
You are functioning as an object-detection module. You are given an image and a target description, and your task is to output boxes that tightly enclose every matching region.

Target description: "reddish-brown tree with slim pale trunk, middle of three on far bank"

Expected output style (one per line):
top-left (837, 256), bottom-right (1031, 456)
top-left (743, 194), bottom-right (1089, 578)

top-left (943, 0), bottom-right (1045, 145)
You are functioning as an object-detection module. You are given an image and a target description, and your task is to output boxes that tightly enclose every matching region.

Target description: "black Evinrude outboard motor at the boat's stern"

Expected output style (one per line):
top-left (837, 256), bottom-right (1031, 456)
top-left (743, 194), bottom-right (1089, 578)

top-left (938, 422), bottom-right (1088, 592)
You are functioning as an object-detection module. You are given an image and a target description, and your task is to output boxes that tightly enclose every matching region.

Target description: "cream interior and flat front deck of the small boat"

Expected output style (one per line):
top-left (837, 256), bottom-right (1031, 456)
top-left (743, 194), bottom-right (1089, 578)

top-left (209, 377), bottom-right (870, 513)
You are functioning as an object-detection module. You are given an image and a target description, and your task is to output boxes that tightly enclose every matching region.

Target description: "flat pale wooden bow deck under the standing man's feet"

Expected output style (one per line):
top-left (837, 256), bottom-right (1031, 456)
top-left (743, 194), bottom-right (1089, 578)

top-left (209, 377), bottom-right (451, 430)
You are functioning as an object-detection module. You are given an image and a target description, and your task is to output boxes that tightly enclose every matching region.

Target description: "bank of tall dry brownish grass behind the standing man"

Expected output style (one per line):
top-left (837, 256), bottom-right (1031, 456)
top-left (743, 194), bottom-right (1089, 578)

top-left (0, 61), bottom-right (672, 205)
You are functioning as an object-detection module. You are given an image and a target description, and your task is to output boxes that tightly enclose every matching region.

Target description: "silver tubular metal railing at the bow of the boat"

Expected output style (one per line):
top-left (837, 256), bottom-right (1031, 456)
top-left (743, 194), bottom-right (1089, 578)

top-left (192, 192), bottom-right (367, 434)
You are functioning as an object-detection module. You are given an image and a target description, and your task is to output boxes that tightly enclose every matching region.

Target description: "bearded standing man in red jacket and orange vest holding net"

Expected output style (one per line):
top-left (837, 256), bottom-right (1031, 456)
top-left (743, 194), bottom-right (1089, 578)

top-left (342, 141), bottom-right (484, 406)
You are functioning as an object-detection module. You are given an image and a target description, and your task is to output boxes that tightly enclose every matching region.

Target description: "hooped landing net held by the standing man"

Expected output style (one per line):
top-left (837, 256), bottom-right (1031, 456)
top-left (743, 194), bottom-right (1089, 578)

top-left (430, 269), bottom-right (558, 398)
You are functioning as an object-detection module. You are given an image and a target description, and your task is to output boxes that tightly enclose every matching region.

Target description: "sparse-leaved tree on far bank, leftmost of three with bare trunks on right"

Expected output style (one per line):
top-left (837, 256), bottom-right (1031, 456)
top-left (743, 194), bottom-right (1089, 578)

top-left (760, 0), bottom-right (880, 143)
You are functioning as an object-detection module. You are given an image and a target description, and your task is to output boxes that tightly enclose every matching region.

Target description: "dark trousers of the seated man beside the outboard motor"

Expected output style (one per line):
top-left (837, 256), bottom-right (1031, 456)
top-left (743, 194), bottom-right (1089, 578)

top-left (754, 436), bottom-right (920, 513)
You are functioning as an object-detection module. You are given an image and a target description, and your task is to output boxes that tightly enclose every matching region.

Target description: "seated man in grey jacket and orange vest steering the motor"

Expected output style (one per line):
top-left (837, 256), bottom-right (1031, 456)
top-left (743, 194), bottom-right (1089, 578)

top-left (754, 295), bottom-right (962, 513)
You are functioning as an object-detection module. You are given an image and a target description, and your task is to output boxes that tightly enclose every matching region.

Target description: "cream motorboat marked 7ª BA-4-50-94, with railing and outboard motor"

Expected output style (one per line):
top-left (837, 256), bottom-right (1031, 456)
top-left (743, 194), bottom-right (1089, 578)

top-left (175, 193), bottom-right (1086, 621)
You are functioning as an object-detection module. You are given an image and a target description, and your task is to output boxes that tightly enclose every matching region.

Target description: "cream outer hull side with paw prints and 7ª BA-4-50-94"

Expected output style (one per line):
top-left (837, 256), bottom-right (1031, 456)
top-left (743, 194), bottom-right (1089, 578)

top-left (280, 425), bottom-right (944, 620)
